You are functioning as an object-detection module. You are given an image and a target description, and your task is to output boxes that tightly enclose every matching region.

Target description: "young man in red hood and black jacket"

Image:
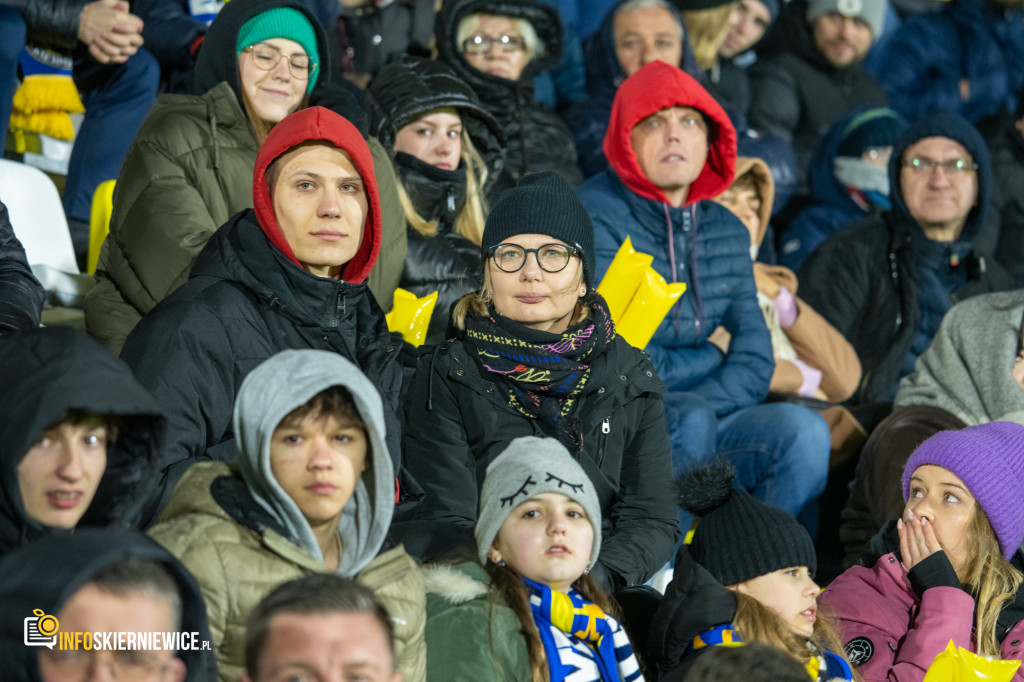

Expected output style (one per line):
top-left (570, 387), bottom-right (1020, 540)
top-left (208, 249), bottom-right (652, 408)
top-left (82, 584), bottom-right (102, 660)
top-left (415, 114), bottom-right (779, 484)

top-left (121, 106), bottom-right (401, 521)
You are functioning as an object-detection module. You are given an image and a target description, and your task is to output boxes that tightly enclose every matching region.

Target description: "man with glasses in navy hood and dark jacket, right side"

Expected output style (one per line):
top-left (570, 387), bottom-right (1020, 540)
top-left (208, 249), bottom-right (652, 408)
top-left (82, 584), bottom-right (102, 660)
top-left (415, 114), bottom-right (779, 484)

top-left (798, 107), bottom-right (1013, 403)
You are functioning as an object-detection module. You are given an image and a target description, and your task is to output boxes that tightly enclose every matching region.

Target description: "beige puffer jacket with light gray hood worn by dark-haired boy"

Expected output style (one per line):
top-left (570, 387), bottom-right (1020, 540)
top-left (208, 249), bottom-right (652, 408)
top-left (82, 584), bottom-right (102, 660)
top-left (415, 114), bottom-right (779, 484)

top-left (150, 350), bottom-right (425, 682)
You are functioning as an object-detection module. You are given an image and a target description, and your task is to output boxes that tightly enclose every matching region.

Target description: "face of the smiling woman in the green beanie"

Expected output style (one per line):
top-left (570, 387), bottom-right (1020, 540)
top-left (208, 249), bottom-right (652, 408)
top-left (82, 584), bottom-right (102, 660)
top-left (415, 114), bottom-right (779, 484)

top-left (239, 38), bottom-right (309, 123)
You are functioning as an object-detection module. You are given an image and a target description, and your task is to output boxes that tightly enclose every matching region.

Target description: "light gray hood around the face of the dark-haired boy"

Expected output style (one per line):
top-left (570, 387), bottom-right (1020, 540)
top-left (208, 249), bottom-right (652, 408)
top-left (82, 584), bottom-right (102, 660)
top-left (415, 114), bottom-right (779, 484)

top-left (233, 350), bottom-right (394, 578)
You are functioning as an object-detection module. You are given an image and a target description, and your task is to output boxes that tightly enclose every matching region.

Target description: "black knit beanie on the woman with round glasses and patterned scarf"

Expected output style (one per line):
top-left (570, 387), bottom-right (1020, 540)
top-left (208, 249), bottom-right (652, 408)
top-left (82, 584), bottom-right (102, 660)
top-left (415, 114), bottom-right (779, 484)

top-left (480, 171), bottom-right (596, 288)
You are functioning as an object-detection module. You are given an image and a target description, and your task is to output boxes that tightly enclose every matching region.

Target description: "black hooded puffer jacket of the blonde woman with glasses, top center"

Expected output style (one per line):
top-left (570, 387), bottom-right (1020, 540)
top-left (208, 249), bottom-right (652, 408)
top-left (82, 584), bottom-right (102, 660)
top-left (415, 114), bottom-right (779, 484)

top-left (435, 0), bottom-right (584, 197)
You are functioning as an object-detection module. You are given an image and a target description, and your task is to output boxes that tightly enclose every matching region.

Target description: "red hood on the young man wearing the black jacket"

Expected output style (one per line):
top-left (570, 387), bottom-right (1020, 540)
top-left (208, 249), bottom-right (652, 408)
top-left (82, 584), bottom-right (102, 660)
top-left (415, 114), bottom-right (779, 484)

top-left (253, 106), bottom-right (381, 283)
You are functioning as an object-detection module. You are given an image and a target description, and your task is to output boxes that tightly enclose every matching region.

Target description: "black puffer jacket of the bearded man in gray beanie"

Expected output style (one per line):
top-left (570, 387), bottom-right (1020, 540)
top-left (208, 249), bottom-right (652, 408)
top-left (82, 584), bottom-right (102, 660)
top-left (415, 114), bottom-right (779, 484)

top-left (748, 11), bottom-right (886, 195)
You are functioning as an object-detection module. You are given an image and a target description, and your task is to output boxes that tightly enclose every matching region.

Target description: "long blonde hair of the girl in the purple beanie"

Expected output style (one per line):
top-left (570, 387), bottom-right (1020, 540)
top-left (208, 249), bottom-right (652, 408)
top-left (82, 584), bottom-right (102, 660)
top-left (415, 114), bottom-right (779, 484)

top-left (957, 504), bottom-right (1024, 658)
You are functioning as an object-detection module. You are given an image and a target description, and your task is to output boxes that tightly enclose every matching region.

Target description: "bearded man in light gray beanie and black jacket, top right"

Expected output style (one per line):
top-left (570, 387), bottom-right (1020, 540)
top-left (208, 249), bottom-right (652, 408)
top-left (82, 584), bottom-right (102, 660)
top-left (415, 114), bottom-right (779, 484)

top-left (750, 0), bottom-right (887, 196)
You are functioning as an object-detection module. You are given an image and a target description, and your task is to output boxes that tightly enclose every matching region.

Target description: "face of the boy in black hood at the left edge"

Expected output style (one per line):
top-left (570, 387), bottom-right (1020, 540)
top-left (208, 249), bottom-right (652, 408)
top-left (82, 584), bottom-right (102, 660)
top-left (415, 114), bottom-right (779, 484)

top-left (17, 422), bottom-right (106, 528)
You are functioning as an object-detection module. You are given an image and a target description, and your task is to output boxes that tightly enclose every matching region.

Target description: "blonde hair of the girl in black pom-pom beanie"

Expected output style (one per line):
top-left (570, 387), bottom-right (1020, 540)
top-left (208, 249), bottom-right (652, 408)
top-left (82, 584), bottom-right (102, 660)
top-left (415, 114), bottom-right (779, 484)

top-left (729, 588), bottom-right (861, 680)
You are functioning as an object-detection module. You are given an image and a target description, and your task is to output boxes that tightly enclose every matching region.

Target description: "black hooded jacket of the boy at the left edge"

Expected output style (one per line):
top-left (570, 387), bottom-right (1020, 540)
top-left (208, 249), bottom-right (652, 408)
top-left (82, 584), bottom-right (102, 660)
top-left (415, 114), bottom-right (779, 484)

top-left (0, 327), bottom-right (165, 557)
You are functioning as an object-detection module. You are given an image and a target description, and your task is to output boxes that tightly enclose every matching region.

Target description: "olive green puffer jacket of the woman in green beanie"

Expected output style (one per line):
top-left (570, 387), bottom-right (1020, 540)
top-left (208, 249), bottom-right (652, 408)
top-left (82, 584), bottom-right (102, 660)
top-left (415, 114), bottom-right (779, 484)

top-left (85, 82), bottom-right (407, 353)
